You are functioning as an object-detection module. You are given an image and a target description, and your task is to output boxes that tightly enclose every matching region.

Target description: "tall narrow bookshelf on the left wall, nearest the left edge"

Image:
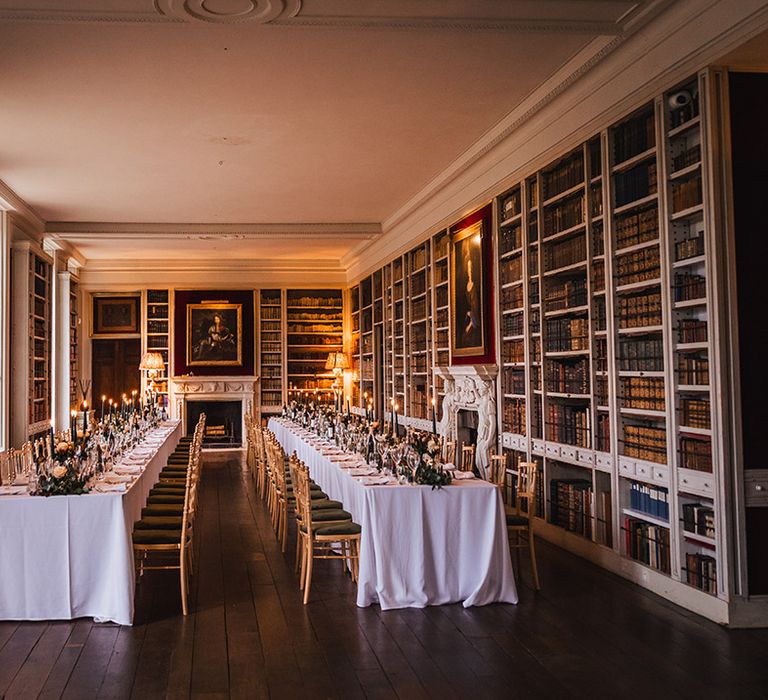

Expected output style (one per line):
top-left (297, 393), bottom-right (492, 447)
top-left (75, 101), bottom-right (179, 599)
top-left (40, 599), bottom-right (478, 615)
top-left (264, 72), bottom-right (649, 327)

top-left (27, 251), bottom-right (53, 437)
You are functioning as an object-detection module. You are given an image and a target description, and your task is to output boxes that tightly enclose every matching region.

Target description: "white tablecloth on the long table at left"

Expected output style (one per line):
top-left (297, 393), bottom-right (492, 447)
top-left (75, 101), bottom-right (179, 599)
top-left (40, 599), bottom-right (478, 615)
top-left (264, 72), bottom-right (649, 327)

top-left (0, 421), bottom-right (181, 625)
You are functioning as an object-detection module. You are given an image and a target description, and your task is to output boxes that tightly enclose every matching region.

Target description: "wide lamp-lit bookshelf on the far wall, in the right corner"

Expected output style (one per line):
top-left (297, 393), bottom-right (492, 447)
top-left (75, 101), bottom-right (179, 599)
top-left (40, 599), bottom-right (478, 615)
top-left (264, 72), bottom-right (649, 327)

top-left (285, 289), bottom-right (343, 401)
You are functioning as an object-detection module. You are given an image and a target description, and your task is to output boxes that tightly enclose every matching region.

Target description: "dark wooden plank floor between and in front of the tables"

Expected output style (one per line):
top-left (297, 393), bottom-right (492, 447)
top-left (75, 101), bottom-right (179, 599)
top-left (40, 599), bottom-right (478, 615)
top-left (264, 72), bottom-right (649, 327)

top-left (0, 453), bottom-right (768, 700)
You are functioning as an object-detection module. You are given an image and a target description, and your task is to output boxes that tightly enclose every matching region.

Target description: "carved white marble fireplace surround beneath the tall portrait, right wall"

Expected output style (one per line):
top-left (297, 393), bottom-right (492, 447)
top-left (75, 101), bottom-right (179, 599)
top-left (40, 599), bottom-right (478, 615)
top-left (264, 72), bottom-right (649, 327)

top-left (435, 365), bottom-right (499, 478)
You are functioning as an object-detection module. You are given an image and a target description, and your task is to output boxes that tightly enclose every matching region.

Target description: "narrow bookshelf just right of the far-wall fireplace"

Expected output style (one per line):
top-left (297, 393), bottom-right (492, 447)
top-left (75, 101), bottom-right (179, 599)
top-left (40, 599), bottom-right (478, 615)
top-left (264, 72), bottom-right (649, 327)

top-left (259, 289), bottom-right (284, 413)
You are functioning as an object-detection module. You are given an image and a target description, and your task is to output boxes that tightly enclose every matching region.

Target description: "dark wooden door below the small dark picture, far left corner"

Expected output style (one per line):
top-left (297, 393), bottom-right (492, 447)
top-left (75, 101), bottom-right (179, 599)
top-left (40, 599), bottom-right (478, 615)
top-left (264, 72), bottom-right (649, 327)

top-left (91, 338), bottom-right (141, 405)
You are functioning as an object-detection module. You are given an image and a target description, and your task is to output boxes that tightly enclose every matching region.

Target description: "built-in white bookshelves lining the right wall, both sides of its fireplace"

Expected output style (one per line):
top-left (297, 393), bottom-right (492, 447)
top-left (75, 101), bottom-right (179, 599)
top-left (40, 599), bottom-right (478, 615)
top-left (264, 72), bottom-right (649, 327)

top-left (344, 72), bottom-right (733, 619)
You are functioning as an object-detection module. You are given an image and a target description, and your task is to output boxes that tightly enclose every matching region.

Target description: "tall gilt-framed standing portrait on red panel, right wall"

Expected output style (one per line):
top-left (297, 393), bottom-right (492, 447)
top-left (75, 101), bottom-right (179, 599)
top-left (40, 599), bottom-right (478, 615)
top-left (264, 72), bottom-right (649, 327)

top-left (451, 221), bottom-right (486, 357)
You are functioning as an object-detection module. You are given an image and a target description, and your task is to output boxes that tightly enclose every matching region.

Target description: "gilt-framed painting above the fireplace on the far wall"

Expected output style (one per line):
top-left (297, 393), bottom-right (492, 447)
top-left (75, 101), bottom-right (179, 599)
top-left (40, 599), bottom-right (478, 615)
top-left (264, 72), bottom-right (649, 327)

top-left (187, 302), bottom-right (243, 367)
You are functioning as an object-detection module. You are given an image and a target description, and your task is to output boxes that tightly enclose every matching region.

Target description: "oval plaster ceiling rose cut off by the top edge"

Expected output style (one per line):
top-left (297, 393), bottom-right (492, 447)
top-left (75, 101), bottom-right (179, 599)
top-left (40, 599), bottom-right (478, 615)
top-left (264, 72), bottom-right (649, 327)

top-left (157, 0), bottom-right (301, 24)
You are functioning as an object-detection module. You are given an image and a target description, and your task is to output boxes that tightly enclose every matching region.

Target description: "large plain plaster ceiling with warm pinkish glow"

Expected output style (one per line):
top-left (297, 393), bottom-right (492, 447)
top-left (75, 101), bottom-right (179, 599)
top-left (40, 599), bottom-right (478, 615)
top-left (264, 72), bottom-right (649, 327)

top-left (0, 0), bottom-right (649, 260)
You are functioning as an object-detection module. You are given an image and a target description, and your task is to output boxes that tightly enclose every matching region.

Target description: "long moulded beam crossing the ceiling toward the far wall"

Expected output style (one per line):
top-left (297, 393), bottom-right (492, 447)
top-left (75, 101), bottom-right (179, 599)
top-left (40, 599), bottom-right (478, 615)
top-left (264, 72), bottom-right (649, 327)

top-left (45, 221), bottom-right (381, 242)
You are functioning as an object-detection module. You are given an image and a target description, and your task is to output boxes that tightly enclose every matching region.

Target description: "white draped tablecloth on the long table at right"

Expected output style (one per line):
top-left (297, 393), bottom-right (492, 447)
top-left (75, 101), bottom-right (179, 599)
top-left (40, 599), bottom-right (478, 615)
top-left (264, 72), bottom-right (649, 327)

top-left (269, 418), bottom-right (517, 610)
